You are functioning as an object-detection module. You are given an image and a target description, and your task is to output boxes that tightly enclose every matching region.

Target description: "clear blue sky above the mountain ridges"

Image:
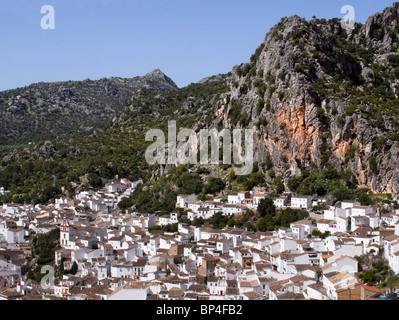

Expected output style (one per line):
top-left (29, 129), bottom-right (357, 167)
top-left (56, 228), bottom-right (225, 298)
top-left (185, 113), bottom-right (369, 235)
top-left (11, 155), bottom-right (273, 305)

top-left (0, 0), bottom-right (395, 91)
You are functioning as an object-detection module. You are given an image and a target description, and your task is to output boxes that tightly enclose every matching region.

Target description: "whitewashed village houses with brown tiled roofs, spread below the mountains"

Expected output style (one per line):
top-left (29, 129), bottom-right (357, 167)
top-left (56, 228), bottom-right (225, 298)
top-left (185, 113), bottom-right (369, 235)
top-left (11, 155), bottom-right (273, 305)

top-left (0, 181), bottom-right (399, 300)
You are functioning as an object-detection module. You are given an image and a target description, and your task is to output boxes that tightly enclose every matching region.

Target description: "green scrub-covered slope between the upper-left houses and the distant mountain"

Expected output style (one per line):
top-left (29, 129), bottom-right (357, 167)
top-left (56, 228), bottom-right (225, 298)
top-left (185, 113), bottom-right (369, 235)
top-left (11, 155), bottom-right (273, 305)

top-left (0, 80), bottom-right (227, 204)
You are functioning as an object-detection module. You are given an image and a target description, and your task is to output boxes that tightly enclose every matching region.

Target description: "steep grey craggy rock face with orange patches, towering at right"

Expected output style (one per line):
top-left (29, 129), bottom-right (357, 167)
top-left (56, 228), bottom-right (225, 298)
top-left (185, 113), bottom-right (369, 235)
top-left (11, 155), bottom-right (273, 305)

top-left (203, 4), bottom-right (399, 194)
